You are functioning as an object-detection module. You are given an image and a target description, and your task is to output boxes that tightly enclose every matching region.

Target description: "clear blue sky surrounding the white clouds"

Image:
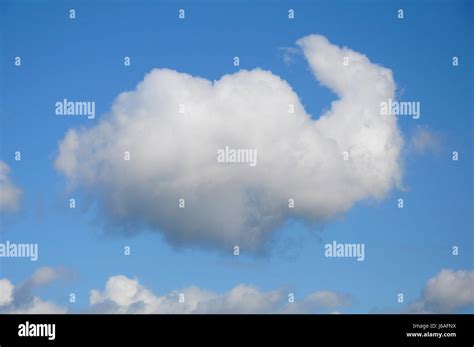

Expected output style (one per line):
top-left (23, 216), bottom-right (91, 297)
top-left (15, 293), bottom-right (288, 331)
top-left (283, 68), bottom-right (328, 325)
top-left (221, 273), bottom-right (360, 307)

top-left (0, 1), bottom-right (474, 313)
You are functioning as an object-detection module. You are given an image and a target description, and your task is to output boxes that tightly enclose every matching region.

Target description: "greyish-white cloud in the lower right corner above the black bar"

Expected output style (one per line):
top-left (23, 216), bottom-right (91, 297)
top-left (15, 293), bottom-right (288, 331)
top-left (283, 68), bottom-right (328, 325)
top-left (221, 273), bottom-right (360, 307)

top-left (409, 269), bottom-right (474, 313)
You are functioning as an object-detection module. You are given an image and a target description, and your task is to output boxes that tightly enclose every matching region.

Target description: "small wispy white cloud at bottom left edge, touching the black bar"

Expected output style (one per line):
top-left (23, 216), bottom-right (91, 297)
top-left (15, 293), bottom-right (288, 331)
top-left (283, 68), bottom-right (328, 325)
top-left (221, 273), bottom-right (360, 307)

top-left (0, 267), bottom-right (66, 314)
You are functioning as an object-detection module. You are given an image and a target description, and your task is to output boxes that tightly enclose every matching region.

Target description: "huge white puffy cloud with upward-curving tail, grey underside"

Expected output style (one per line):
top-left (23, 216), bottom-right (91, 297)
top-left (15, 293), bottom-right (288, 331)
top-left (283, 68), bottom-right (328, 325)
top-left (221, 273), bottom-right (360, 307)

top-left (55, 35), bottom-right (402, 252)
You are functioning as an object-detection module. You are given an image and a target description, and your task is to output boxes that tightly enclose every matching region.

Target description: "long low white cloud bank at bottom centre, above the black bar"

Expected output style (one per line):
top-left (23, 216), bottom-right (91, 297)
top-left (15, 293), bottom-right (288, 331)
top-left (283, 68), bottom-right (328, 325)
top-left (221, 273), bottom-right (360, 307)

top-left (89, 275), bottom-right (350, 313)
